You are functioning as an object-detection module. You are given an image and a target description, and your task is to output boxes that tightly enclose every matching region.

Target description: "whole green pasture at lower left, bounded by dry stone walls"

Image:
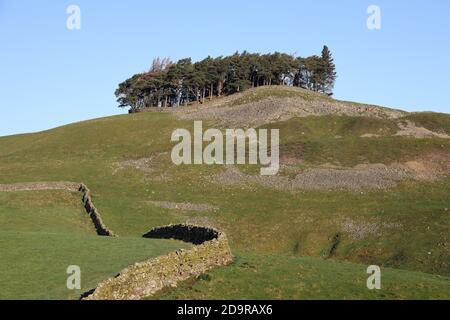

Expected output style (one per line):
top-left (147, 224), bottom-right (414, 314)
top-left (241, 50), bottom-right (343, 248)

top-left (0, 191), bottom-right (190, 299)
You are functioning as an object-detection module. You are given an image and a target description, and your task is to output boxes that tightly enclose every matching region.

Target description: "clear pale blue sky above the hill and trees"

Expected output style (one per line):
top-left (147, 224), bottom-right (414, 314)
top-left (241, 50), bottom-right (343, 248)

top-left (0, 0), bottom-right (450, 135)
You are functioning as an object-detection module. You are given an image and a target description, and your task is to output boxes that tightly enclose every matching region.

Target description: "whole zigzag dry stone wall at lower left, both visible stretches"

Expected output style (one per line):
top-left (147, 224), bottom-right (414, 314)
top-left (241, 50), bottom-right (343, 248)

top-left (0, 182), bottom-right (233, 300)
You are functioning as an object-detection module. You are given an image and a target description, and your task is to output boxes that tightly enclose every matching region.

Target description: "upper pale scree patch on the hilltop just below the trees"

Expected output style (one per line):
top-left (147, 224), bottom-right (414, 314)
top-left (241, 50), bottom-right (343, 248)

top-left (175, 87), bottom-right (406, 128)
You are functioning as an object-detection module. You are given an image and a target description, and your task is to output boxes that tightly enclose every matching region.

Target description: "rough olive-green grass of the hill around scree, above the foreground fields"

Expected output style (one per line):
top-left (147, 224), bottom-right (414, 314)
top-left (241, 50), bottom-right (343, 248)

top-left (0, 86), bottom-right (450, 298)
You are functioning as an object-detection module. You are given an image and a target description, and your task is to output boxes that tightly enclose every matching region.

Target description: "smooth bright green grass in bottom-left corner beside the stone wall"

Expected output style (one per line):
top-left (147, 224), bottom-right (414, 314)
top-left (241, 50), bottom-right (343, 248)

top-left (0, 231), bottom-right (189, 299)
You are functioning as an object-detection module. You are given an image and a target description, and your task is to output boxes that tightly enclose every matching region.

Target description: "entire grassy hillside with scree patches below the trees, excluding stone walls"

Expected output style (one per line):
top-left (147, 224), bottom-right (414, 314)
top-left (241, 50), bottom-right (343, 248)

top-left (0, 86), bottom-right (450, 299)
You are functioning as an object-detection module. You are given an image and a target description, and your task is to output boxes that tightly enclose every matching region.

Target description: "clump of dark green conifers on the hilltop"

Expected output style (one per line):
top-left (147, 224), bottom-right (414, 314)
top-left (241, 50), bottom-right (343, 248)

top-left (115, 46), bottom-right (336, 111)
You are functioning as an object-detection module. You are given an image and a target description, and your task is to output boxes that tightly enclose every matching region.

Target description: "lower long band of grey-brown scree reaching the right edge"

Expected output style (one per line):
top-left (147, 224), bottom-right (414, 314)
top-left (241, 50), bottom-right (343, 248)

top-left (207, 154), bottom-right (450, 191)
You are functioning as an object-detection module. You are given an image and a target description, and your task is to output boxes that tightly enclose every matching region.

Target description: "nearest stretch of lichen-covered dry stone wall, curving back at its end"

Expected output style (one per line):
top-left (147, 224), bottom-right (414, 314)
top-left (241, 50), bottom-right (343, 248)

top-left (85, 225), bottom-right (233, 300)
